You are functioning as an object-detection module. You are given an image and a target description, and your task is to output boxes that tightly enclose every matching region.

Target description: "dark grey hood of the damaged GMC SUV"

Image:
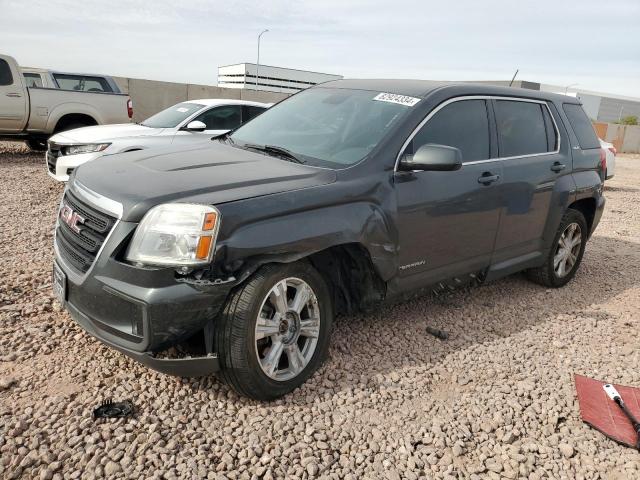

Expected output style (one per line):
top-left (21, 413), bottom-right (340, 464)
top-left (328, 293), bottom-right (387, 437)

top-left (74, 142), bottom-right (336, 222)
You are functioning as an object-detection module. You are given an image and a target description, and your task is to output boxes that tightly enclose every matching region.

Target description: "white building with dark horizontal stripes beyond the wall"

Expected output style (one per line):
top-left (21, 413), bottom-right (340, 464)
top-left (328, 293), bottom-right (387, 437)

top-left (218, 63), bottom-right (343, 93)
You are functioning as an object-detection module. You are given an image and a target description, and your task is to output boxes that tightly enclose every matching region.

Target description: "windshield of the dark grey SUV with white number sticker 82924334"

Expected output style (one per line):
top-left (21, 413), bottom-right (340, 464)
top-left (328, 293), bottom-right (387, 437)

top-left (231, 87), bottom-right (417, 168)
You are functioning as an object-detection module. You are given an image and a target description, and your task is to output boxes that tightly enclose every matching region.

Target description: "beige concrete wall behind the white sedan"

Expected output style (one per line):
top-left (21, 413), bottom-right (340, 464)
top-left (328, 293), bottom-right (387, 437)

top-left (113, 77), bottom-right (289, 122)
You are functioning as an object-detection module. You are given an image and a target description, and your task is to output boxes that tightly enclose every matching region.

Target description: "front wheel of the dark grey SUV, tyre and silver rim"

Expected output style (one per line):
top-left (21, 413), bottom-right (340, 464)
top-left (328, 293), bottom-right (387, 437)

top-left (215, 262), bottom-right (333, 400)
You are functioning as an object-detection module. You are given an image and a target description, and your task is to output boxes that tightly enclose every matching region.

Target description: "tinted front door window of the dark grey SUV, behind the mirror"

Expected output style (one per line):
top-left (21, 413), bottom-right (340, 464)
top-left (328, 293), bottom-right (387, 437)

top-left (406, 100), bottom-right (489, 162)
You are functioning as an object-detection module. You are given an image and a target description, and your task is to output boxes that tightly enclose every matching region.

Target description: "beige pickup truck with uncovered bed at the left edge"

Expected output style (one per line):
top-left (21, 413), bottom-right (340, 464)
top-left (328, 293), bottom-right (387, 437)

top-left (0, 54), bottom-right (133, 150)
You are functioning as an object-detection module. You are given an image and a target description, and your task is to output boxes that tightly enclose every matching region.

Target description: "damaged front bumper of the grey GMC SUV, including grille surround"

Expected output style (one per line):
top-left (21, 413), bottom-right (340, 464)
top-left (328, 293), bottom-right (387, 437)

top-left (54, 196), bottom-right (235, 376)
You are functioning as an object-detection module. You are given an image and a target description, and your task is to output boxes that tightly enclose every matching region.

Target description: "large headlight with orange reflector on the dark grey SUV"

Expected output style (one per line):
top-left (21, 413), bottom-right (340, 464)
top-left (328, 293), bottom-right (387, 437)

top-left (127, 203), bottom-right (220, 266)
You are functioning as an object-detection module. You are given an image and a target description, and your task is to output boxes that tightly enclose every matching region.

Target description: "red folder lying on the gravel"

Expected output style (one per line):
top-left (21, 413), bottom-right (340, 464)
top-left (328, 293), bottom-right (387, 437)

top-left (575, 375), bottom-right (640, 448)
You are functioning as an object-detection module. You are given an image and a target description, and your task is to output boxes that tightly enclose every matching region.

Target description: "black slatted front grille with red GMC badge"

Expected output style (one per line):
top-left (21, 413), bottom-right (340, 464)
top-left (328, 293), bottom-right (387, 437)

top-left (56, 191), bottom-right (116, 273)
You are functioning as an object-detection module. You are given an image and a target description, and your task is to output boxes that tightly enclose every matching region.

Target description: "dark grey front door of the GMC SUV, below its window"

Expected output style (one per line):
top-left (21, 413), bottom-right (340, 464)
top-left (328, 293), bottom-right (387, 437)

top-left (396, 161), bottom-right (502, 285)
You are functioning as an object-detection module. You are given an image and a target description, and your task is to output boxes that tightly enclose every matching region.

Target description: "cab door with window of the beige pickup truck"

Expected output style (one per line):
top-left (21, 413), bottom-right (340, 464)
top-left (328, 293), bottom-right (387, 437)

top-left (0, 56), bottom-right (28, 133)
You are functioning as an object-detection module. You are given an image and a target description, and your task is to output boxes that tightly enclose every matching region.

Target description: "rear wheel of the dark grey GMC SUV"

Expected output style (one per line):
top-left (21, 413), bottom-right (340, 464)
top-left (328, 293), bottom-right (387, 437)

top-left (527, 208), bottom-right (588, 288)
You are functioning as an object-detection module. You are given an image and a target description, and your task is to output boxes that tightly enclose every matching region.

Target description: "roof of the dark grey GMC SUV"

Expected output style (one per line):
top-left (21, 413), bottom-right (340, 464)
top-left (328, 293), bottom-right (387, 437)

top-left (317, 79), bottom-right (580, 103)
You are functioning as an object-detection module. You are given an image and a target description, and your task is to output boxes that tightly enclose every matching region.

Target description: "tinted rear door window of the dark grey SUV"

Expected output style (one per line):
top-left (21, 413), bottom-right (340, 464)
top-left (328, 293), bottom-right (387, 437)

top-left (495, 100), bottom-right (557, 157)
